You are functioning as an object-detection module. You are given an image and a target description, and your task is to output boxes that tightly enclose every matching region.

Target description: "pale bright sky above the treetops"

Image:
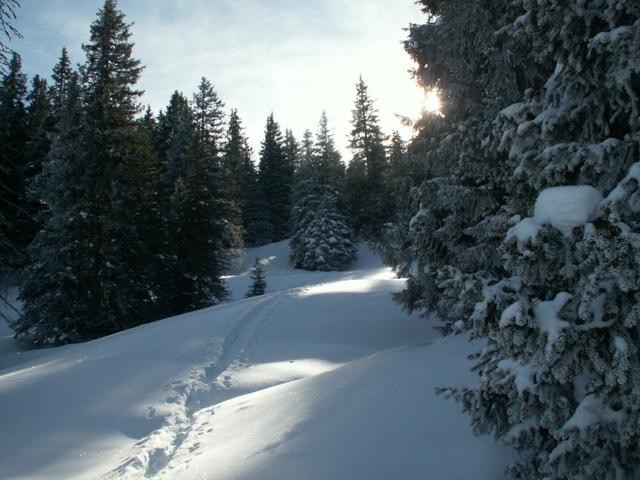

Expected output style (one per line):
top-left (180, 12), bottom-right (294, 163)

top-left (9, 0), bottom-right (425, 161)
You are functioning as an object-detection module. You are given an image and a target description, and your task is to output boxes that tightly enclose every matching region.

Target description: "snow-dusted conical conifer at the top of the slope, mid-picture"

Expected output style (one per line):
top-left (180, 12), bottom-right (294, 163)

top-left (289, 112), bottom-right (357, 270)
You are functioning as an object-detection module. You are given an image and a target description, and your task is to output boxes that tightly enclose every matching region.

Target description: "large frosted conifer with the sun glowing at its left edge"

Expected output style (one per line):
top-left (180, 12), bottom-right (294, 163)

top-left (383, 0), bottom-right (545, 331)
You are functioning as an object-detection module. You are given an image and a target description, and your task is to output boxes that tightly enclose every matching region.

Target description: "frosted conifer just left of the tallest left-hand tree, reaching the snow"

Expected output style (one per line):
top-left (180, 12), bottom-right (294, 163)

top-left (11, 75), bottom-right (99, 345)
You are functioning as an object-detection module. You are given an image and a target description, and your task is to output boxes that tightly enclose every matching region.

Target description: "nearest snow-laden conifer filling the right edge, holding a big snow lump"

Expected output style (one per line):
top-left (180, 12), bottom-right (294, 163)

top-left (452, 1), bottom-right (640, 479)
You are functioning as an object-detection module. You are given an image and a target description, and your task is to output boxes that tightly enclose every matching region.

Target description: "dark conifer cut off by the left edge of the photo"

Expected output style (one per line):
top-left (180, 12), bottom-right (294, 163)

top-left (0, 53), bottom-right (30, 268)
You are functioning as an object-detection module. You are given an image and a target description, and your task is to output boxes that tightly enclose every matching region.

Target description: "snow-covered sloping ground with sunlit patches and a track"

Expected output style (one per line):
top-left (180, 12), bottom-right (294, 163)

top-left (0, 242), bottom-right (506, 480)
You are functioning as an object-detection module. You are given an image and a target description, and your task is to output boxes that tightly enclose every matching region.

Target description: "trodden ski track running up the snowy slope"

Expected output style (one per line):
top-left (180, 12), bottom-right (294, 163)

top-left (104, 288), bottom-right (286, 480)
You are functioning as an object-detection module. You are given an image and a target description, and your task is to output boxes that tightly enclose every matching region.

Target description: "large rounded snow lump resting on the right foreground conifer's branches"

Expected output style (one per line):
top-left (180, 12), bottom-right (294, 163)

top-left (507, 185), bottom-right (603, 244)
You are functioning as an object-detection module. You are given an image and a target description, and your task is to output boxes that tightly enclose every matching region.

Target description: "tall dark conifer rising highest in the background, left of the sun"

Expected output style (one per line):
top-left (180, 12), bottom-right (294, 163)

top-left (346, 77), bottom-right (391, 239)
